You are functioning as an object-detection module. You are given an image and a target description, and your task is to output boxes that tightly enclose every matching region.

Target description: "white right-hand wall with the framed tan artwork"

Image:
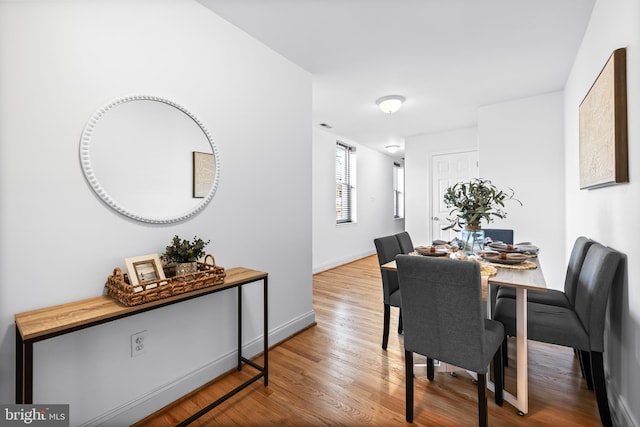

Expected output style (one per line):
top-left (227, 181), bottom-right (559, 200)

top-left (565, 0), bottom-right (640, 425)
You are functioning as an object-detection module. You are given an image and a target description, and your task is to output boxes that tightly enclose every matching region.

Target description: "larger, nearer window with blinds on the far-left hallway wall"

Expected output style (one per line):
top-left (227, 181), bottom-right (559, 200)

top-left (336, 142), bottom-right (356, 224)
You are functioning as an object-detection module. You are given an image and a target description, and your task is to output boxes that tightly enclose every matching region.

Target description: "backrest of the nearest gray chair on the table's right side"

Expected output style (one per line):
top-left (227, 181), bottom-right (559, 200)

top-left (574, 243), bottom-right (622, 352)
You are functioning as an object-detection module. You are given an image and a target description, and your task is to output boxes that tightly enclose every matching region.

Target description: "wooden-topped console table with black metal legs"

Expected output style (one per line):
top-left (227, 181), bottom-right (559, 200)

top-left (15, 267), bottom-right (269, 425)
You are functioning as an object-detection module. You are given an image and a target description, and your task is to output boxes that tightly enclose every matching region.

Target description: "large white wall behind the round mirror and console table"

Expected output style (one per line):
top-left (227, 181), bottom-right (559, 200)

top-left (0, 0), bottom-right (315, 425)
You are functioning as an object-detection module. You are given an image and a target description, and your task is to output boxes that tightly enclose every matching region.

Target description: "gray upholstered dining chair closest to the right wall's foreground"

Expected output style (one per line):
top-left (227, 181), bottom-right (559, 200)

top-left (493, 242), bottom-right (623, 426)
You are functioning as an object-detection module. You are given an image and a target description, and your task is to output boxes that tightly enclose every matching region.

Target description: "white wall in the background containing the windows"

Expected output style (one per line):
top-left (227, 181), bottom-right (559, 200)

top-left (312, 128), bottom-right (404, 272)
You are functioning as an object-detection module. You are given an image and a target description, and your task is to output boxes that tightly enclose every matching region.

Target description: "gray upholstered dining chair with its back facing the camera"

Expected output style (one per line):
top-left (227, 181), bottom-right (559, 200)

top-left (396, 255), bottom-right (504, 426)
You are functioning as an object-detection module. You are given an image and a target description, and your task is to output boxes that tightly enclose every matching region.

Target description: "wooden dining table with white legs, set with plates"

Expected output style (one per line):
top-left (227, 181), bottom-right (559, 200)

top-left (380, 254), bottom-right (547, 415)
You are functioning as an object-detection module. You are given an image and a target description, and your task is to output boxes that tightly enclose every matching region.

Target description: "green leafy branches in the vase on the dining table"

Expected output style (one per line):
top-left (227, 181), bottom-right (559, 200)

top-left (443, 178), bottom-right (522, 231)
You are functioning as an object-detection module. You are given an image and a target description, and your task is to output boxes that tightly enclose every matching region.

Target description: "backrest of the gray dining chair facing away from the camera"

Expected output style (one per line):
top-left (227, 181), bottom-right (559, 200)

top-left (396, 255), bottom-right (495, 374)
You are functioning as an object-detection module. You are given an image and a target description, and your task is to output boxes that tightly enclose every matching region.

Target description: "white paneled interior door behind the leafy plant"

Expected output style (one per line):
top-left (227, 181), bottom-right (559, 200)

top-left (431, 150), bottom-right (478, 241)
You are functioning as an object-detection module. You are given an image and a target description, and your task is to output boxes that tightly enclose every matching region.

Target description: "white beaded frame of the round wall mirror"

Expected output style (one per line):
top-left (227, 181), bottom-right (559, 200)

top-left (80, 95), bottom-right (220, 224)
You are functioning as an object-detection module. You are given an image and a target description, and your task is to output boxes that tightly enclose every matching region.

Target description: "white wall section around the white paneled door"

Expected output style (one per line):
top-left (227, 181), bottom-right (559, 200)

top-left (405, 127), bottom-right (478, 245)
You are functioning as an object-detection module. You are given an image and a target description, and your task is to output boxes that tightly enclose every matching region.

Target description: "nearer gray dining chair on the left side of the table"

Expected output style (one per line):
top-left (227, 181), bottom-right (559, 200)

top-left (373, 235), bottom-right (402, 350)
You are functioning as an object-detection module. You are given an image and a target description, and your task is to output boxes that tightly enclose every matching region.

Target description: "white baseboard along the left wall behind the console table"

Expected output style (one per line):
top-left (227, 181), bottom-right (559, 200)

top-left (81, 311), bottom-right (316, 427)
